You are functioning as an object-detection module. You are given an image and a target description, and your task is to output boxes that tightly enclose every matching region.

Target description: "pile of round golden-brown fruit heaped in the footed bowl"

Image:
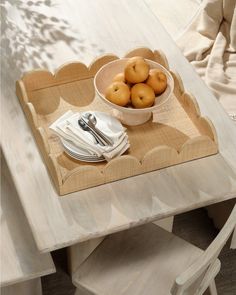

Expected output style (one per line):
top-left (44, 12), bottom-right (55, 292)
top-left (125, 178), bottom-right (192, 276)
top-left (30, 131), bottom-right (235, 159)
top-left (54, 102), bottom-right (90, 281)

top-left (105, 56), bottom-right (167, 109)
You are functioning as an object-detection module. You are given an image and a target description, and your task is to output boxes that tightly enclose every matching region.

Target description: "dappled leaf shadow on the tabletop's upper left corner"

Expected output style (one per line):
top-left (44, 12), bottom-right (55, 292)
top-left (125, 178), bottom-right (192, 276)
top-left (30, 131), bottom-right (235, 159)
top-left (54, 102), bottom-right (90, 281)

top-left (0, 0), bottom-right (90, 80)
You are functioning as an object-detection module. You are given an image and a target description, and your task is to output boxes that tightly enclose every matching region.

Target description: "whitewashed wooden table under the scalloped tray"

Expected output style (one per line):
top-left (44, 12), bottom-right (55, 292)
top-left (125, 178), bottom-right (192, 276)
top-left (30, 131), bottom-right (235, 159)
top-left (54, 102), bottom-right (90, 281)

top-left (1, 0), bottom-right (236, 252)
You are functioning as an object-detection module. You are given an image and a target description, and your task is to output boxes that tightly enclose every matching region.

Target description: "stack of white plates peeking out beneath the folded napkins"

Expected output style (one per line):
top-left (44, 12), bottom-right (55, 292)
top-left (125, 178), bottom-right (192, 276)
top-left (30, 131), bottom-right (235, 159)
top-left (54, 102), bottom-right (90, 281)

top-left (61, 138), bottom-right (105, 162)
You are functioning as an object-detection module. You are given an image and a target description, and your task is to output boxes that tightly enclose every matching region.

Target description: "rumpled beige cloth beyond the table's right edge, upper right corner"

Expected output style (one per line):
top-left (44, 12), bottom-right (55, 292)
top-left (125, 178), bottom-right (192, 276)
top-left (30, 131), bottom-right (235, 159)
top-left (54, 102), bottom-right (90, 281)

top-left (177, 0), bottom-right (236, 121)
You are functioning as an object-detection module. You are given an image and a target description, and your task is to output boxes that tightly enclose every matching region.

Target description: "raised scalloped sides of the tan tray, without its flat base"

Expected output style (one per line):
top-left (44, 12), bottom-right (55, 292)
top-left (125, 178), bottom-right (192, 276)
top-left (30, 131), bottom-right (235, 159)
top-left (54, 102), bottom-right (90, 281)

top-left (16, 48), bottom-right (218, 195)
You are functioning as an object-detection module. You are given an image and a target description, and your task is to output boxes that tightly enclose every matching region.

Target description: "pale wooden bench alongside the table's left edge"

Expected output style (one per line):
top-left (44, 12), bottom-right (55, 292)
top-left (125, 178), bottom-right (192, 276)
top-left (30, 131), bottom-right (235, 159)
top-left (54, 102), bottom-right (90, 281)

top-left (1, 159), bottom-right (56, 288)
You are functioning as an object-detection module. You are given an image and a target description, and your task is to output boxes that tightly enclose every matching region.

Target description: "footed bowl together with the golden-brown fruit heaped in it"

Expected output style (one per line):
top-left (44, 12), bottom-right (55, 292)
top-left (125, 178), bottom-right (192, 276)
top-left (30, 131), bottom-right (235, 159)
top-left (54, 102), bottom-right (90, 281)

top-left (94, 57), bottom-right (174, 126)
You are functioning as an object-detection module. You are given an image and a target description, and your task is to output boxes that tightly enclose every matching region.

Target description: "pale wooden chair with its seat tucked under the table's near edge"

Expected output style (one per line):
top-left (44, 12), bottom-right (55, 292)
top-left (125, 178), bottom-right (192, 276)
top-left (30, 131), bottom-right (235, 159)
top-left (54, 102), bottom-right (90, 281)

top-left (73, 206), bottom-right (236, 295)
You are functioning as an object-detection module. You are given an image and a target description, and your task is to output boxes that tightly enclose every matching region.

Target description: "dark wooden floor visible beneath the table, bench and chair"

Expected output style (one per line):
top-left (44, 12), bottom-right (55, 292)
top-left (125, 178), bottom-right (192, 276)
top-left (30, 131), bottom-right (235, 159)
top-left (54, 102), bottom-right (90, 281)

top-left (42, 209), bottom-right (236, 295)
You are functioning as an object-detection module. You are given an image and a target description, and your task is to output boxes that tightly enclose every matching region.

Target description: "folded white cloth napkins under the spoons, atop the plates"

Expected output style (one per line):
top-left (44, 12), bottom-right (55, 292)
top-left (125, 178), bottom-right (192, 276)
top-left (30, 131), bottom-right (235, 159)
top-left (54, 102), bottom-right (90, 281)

top-left (49, 111), bottom-right (130, 161)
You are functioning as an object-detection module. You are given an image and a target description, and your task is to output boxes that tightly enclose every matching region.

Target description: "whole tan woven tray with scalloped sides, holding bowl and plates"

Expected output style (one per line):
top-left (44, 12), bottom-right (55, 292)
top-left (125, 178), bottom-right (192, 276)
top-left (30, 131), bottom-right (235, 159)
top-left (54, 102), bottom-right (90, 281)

top-left (16, 48), bottom-right (218, 195)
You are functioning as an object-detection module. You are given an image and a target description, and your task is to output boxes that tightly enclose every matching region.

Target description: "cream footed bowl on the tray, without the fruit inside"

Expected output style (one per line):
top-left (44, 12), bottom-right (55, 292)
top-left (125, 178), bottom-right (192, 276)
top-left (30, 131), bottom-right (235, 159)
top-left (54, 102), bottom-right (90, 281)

top-left (94, 58), bottom-right (174, 126)
